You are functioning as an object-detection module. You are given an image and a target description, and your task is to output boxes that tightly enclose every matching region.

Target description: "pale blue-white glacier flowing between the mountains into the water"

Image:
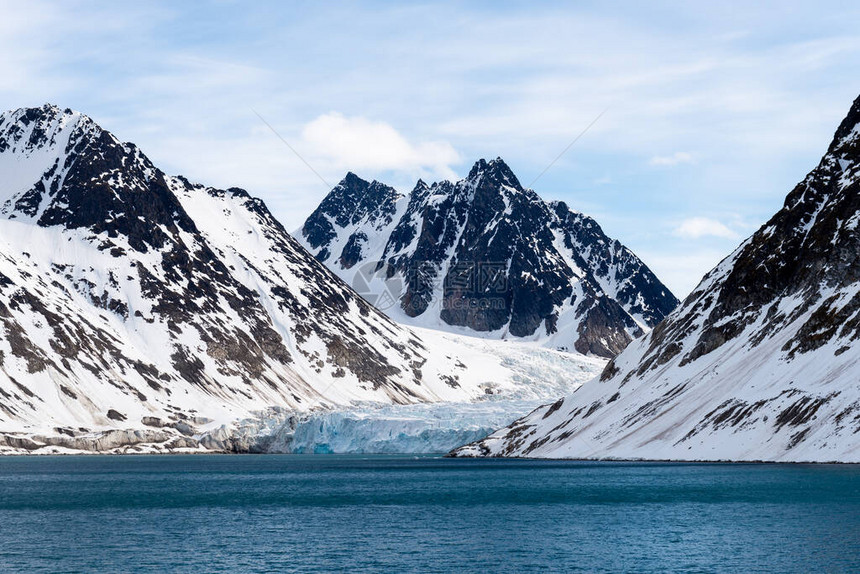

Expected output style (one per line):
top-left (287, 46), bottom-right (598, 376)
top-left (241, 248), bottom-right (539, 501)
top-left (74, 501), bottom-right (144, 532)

top-left (207, 327), bottom-right (606, 454)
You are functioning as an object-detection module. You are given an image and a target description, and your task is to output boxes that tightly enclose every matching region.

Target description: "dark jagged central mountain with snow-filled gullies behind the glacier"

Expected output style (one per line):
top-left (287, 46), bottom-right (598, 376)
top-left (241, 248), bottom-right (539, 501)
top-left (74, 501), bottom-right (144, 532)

top-left (295, 155), bottom-right (678, 357)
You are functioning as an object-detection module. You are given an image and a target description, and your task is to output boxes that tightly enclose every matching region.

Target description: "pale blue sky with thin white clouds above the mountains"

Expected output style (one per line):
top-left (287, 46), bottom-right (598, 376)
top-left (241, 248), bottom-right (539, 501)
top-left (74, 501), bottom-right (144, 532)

top-left (0, 0), bottom-right (860, 298)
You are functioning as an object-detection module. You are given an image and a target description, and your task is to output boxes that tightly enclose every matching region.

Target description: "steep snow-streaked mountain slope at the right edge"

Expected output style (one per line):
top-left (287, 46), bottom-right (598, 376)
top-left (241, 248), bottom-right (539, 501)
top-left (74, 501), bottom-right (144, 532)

top-left (454, 98), bottom-right (860, 462)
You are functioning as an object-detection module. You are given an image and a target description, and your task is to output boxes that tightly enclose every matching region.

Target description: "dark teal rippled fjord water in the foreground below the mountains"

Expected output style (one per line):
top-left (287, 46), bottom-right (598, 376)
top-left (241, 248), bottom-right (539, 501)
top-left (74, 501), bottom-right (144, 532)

top-left (0, 455), bottom-right (860, 572)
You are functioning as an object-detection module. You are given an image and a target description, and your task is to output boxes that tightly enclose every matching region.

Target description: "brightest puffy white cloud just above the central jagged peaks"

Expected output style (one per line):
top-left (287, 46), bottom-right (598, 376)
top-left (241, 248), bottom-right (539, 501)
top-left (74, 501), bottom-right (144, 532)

top-left (302, 112), bottom-right (460, 176)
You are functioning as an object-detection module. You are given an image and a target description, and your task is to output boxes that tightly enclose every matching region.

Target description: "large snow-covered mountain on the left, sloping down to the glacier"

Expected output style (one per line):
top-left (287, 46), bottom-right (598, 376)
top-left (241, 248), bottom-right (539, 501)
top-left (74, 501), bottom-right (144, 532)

top-left (0, 105), bottom-right (596, 451)
